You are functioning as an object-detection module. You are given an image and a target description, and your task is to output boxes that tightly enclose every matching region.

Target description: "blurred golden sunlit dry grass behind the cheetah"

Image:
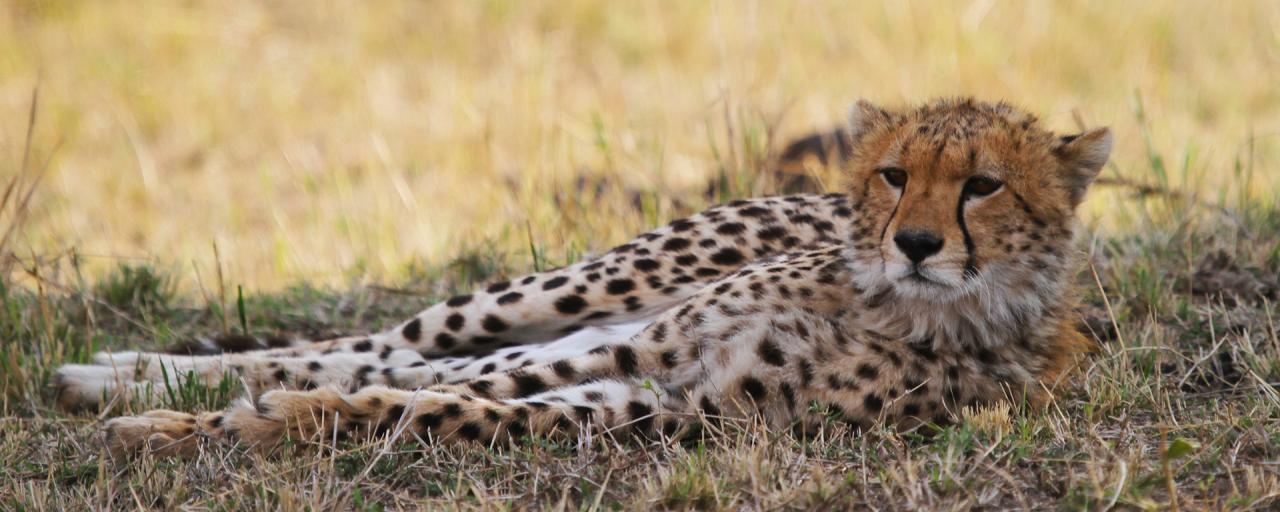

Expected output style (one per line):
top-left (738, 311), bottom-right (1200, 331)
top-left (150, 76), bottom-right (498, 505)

top-left (0, 0), bottom-right (1280, 289)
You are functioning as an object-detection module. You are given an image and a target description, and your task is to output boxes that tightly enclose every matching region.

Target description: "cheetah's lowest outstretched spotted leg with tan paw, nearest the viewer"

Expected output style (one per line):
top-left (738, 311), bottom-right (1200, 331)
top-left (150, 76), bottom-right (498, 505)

top-left (106, 380), bottom-right (687, 456)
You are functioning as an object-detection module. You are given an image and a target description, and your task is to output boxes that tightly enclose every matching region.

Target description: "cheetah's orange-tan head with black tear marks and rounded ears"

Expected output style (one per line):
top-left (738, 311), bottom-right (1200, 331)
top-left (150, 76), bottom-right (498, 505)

top-left (850, 100), bottom-right (1111, 302)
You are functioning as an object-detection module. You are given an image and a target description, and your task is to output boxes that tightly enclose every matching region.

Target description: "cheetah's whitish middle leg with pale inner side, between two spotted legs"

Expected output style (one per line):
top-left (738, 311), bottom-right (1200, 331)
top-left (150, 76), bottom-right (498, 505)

top-left (58, 324), bottom-right (645, 408)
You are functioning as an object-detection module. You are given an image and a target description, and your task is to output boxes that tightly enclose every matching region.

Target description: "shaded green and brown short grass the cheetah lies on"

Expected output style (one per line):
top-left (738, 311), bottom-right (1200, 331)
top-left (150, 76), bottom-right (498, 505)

top-left (0, 185), bottom-right (1280, 509)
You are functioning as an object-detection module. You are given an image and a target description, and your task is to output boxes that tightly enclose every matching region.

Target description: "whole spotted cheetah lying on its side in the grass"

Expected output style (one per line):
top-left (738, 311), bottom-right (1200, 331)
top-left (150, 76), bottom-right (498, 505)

top-left (58, 99), bottom-right (1111, 454)
